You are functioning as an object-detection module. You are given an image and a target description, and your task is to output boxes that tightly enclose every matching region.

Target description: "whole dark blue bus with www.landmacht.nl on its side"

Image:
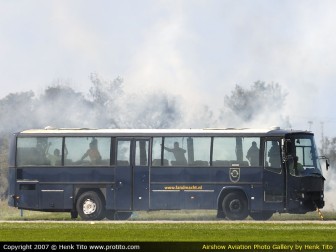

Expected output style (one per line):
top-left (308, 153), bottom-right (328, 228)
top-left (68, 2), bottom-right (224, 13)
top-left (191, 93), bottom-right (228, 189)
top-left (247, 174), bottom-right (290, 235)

top-left (9, 128), bottom-right (325, 220)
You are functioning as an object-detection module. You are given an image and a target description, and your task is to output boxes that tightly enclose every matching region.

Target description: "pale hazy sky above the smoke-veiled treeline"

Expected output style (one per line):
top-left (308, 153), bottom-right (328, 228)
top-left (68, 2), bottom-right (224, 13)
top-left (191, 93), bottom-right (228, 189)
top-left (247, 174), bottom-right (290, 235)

top-left (0, 0), bottom-right (336, 136)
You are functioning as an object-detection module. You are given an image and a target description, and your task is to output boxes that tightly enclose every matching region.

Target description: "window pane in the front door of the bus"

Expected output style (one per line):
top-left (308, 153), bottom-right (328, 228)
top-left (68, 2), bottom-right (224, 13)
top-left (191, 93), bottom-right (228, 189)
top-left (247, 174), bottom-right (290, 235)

top-left (264, 140), bottom-right (281, 173)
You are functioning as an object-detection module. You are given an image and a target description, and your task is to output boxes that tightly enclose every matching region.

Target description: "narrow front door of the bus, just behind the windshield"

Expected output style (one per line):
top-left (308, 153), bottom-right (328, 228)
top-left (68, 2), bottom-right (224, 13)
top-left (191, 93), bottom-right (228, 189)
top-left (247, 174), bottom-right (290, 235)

top-left (263, 138), bottom-right (286, 211)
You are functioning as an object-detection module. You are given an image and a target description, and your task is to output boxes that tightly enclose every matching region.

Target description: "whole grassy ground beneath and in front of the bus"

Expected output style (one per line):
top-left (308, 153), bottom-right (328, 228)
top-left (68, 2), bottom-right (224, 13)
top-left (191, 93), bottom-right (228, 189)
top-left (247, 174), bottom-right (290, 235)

top-left (0, 202), bottom-right (336, 242)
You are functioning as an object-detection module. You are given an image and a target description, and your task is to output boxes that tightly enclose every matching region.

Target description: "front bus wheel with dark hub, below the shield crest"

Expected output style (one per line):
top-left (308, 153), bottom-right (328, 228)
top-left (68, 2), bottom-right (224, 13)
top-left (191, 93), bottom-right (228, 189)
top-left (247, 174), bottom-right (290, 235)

top-left (222, 192), bottom-right (248, 220)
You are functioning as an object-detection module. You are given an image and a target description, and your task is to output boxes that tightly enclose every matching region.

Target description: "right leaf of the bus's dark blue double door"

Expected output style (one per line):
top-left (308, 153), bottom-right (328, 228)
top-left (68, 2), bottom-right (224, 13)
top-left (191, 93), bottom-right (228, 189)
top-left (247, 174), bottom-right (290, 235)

top-left (133, 139), bottom-right (149, 210)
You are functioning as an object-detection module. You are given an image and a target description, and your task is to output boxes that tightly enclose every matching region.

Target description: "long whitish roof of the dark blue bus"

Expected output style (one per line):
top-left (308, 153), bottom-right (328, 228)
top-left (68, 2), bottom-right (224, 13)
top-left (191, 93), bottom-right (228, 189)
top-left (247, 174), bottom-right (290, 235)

top-left (18, 127), bottom-right (313, 136)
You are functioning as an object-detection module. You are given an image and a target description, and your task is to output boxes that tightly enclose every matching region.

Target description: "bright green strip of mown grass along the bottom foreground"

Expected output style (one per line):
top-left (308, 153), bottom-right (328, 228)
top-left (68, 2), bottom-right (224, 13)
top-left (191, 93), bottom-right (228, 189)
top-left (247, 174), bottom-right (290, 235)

top-left (0, 222), bottom-right (336, 242)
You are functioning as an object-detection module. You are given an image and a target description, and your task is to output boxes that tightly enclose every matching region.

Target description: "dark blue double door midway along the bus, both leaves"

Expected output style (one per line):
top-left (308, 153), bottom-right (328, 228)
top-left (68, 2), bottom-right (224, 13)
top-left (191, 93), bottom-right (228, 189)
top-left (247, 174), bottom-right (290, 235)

top-left (115, 138), bottom-right (149, 211)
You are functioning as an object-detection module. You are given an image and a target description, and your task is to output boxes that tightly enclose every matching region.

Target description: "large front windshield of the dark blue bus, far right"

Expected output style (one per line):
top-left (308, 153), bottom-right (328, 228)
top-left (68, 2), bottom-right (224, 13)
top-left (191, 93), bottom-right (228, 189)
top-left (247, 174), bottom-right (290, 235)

top-left (289, 135), bottom-right (322, 176)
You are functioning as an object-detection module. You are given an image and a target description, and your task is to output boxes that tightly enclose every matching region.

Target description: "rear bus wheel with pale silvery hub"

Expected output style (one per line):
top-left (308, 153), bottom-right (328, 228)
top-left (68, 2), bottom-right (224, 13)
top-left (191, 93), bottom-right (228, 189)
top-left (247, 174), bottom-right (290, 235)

top-left (76, 191), bottom-right (105, 220)
